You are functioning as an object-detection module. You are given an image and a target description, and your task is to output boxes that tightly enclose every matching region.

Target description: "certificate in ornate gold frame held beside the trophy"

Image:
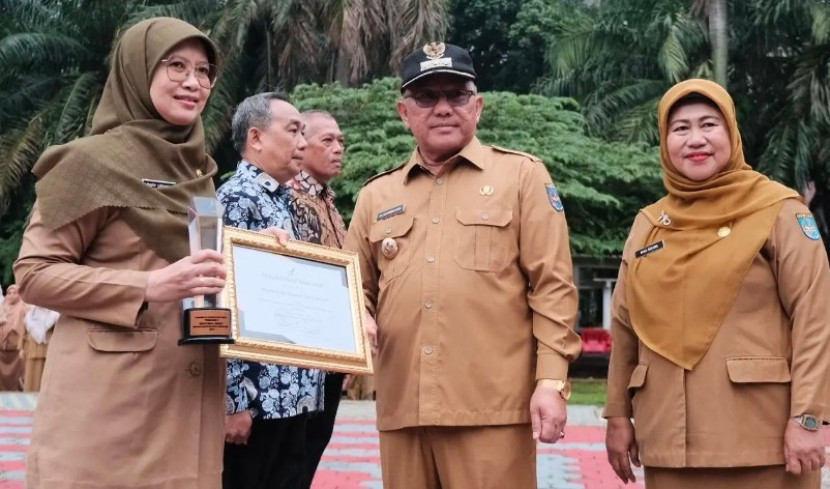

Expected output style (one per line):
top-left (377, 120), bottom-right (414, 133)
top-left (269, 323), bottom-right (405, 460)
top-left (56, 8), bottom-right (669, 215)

top-left (220, 226), bottom-right (372, 374)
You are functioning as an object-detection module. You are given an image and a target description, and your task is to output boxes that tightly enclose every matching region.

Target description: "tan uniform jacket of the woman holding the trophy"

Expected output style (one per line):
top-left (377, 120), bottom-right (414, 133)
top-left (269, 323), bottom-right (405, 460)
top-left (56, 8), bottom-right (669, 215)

top-left (14, 205), bottom-right (224, 489)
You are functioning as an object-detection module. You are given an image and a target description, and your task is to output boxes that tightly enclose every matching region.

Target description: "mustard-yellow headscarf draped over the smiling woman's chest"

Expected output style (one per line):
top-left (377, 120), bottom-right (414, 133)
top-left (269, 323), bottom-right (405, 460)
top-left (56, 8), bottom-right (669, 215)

top-left (626, 80), bottom-right (798, 370)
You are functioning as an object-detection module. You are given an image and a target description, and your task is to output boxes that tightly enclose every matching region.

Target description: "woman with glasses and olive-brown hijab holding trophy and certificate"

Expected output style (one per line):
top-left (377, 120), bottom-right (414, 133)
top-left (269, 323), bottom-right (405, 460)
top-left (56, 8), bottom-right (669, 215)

top-left (14, 18), bottom-right (225, 489)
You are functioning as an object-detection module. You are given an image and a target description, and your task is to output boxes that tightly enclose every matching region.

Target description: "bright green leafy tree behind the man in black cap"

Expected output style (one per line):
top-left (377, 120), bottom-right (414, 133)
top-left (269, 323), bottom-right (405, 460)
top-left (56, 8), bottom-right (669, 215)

top-left (292, 78), bottom-right (662, 255)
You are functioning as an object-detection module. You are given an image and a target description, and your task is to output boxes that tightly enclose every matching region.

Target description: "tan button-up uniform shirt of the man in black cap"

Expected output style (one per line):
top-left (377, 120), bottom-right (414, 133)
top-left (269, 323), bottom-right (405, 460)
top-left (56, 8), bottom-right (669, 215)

top-left (345, 139), bottom-right (580, 430)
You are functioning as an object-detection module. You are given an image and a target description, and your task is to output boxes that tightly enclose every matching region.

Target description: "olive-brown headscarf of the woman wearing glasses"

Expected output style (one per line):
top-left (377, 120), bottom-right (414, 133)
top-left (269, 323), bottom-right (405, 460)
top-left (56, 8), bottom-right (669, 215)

top-left (32, 17), bottom-right (218, 262)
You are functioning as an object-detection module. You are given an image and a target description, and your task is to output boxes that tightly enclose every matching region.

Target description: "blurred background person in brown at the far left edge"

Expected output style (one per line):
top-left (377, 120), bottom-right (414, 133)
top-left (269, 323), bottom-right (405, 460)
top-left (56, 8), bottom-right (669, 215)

top-left (0, 285), bottom-right (28, 391)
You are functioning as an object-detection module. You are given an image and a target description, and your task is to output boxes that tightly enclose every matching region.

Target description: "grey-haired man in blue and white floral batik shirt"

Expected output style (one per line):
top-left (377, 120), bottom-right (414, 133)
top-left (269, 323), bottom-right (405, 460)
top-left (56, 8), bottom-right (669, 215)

top-left (217, 93), bottom-right (325, 489)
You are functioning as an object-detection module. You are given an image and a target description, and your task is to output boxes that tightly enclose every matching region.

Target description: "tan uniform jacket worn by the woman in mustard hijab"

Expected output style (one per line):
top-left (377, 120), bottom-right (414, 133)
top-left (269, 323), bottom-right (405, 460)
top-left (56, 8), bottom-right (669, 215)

top-left (605, 200), bottom-right (830, 467)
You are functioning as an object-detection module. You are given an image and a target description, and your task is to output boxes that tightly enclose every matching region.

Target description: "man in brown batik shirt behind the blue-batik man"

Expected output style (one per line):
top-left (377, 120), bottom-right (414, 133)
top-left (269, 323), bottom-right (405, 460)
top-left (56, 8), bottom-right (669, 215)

top-left (291, 111), bottom-right (346, 488)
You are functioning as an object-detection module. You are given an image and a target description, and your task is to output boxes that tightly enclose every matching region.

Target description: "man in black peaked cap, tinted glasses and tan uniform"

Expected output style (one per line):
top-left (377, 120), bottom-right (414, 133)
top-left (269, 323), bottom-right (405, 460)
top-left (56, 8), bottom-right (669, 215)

top-left (345, 43), bottom-right (580, 489)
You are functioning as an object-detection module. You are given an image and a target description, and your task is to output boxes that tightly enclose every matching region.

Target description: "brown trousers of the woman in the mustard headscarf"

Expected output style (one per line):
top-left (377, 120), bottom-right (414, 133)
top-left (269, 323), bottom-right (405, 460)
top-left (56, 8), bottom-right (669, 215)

top-left (645, 465), bottom-right (821, 489)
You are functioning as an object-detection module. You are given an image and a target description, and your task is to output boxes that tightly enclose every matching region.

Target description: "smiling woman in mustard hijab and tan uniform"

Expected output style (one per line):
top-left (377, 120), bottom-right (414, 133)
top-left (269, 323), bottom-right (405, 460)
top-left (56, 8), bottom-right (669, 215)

top-left (604, 80), bottom-right (830, 489)
